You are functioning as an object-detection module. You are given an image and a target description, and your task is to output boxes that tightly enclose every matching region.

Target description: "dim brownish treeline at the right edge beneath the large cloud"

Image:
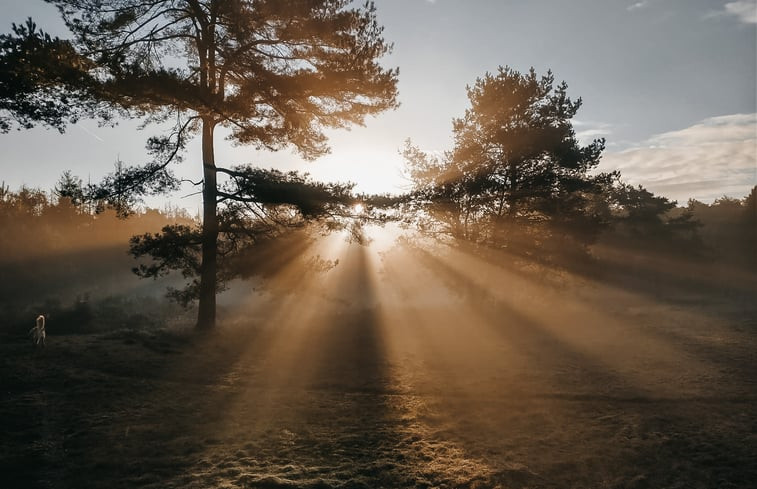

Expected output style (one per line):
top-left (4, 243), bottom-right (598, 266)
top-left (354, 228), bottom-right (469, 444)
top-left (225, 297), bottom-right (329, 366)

top-left (576, 186), bottom-right (757, 302)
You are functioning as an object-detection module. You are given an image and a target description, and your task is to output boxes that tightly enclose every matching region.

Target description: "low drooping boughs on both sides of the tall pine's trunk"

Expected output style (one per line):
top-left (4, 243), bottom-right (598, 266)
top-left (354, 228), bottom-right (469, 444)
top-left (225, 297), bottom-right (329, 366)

top-left (130, 167), bottom-right (364, 306)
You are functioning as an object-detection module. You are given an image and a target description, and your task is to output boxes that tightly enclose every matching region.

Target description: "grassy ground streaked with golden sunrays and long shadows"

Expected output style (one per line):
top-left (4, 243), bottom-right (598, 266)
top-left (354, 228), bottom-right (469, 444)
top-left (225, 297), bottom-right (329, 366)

top-left (0, 270), bottom-right (757, 489)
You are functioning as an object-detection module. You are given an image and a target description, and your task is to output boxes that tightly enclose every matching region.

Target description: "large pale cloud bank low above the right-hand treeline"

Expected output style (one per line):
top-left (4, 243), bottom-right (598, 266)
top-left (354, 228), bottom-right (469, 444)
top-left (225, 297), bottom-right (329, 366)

top-left (600, 114), bottom-right (757, 203)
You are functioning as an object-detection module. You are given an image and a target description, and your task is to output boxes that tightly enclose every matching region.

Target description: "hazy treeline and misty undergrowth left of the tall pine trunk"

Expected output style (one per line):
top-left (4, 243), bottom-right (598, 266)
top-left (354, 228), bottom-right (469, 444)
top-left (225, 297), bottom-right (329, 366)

top-left (0, 185), bottom-right (196, 333)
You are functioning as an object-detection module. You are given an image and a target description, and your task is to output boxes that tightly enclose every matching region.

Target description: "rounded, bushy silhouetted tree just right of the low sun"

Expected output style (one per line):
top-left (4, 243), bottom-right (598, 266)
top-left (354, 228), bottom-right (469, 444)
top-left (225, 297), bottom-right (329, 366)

top-left (404, 67), bottom-right (617, 262)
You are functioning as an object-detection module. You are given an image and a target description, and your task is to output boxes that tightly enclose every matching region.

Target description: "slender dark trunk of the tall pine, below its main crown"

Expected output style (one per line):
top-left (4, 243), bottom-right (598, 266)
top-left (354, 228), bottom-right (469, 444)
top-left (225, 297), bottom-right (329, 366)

top-left (197, 119), bottom-right (218, 329)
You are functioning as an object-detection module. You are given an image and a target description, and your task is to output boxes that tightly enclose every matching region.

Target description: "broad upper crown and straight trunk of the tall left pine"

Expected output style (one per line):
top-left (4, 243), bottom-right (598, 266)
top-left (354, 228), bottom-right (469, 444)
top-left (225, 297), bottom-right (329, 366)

top-left (0, 0), bottom-right (397, 328)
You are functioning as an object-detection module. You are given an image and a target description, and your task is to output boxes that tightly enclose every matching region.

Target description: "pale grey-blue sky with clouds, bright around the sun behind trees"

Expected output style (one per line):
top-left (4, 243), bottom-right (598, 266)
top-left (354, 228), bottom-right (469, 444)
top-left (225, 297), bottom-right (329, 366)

top-left (0, 0), bottom-right (757, 213)
